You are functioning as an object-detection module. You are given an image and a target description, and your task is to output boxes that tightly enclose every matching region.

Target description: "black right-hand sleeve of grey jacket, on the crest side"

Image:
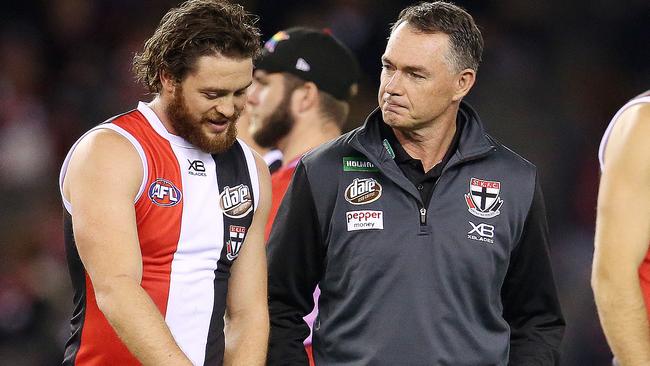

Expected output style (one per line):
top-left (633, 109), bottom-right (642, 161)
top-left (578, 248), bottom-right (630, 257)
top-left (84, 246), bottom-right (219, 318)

top-left (501, 179), bottom-right (565, 366)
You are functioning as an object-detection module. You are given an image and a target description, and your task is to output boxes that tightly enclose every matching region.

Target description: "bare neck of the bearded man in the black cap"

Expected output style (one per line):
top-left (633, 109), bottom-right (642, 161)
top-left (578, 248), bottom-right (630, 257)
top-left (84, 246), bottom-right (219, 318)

top-left (278, 120), bottom-right (341, 165)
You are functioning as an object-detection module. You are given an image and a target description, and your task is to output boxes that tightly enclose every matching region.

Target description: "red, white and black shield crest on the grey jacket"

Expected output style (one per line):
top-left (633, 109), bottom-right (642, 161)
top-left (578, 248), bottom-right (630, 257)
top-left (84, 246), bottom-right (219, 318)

top-left (465, 178), bottom-right (503, 219)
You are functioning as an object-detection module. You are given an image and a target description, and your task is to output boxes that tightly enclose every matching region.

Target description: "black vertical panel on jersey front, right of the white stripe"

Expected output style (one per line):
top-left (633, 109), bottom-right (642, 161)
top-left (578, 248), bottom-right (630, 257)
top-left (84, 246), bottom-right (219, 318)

top-left (204, 141), bottom-right (257, 365)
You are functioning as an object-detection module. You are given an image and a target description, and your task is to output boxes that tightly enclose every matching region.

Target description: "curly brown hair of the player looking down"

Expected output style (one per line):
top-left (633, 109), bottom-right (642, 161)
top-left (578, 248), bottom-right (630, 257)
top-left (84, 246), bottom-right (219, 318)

top-left (133, 0), bottom-right (261, 93)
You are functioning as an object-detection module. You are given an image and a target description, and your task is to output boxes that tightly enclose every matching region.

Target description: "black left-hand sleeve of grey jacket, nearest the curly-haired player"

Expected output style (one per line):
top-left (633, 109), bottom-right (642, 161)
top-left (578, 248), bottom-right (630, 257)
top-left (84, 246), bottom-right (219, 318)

top-left (267, 162), bottom-right (324, 365)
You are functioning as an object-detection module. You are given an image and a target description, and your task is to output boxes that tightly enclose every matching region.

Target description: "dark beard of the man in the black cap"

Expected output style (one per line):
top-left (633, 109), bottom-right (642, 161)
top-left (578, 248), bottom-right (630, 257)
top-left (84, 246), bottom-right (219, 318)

top-left (251, 95), bottom-right (294, 148)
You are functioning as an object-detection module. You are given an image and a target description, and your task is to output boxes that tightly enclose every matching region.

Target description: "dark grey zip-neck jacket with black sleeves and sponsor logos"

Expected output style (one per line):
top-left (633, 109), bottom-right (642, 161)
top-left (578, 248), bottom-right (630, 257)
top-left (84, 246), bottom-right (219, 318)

top-left (268, 103), bottom-right (564, 366)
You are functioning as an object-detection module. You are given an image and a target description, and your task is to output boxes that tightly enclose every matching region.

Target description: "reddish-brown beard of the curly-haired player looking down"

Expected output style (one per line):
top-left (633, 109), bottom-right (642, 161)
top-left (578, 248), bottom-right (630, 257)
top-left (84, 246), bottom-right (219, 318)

top-left (167, 85), bottom-right (241, 154)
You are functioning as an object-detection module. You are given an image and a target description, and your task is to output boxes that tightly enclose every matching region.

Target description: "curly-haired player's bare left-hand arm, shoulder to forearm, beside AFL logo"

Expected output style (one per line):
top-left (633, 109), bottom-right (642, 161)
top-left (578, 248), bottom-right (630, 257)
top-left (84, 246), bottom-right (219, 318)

top-left (63, 130), bottom-right (191, 365)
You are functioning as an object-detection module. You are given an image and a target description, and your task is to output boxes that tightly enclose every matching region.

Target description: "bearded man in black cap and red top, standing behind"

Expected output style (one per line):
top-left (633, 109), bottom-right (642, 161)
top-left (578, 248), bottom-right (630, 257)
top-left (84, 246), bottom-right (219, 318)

top-left (248, 27), bottom-right (359, 366)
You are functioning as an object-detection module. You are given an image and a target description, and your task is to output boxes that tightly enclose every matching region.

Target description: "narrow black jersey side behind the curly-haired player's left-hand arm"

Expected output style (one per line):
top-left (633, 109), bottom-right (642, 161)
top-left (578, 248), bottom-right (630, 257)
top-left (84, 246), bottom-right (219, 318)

top-left (62, 209), bottom-right (86, 366)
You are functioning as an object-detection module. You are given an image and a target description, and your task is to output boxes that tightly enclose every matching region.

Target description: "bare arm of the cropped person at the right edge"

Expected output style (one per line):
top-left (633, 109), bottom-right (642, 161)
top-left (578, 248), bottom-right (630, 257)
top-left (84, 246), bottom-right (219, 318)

top-left (591, 104), bottom-right (650, 366)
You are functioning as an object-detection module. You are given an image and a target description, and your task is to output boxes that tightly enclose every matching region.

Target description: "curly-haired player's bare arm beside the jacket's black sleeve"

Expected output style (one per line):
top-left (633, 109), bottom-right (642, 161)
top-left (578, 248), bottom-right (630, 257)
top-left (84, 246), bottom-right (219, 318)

top-left (224, 154), bottom-right (271, 366)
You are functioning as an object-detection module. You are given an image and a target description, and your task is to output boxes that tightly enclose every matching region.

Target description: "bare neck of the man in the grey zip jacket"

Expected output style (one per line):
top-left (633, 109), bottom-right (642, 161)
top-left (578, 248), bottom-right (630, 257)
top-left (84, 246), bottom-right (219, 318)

top-left (393, 109), bottom-right (458, 172)
